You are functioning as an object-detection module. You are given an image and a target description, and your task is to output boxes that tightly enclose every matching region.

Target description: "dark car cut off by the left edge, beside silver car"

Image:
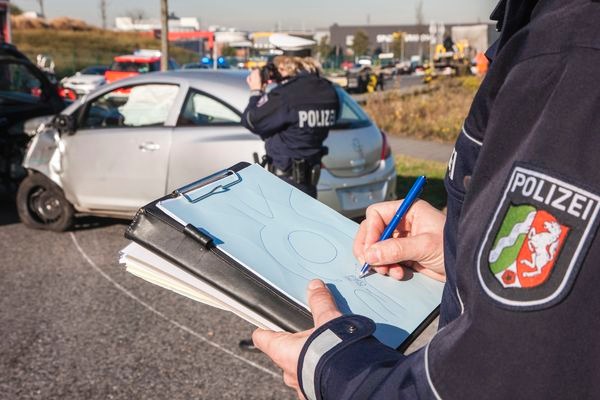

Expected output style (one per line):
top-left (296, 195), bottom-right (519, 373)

top-left (0, 43), bottom-right (65, 195)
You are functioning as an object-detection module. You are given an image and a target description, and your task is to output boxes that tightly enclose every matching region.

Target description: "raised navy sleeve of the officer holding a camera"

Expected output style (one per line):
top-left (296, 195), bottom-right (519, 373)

top-left (242, 90), bottom-right (289, 140)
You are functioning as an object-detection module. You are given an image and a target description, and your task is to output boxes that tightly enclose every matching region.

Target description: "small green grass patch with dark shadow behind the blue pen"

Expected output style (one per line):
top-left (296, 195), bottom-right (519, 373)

top-left (396, 156), bottom-right (447, 210)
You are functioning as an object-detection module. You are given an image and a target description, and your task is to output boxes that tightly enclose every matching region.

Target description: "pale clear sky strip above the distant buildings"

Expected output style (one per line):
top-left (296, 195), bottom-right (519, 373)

top-left (13, 0), bottom-right (496, 30)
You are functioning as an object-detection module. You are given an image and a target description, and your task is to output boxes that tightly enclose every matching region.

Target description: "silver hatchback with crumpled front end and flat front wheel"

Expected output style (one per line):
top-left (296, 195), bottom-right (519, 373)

top-left (17, 70), bottom-right (396, 231)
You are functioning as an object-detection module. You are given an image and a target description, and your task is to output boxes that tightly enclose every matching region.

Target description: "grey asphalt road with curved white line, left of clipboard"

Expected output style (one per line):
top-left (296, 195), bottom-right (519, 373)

top-left (0, 202), bottom-right (296, 400)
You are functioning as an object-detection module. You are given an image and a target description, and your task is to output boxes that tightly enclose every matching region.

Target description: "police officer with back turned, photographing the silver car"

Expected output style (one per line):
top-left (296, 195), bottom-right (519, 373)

top-left (242, 56), bottom-right (339, 197)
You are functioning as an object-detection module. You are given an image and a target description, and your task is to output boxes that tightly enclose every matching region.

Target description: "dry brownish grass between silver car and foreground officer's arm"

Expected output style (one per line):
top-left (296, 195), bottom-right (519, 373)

top-left (364, 76), bottom-right (481, 143)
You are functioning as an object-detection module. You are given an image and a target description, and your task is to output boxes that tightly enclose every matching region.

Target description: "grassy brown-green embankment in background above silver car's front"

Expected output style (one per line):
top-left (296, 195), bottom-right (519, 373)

top-left (13, 28), bottom-right (198, 78)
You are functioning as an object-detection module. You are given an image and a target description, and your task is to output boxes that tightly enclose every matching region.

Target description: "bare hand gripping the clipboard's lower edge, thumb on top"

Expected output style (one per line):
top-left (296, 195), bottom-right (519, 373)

top-left (252, 279), bottom-right (342, 399)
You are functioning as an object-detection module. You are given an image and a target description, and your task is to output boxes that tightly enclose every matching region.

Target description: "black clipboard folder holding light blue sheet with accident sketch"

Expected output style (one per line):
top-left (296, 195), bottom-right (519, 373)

top-left (125, 163), bottom-right (443, 350)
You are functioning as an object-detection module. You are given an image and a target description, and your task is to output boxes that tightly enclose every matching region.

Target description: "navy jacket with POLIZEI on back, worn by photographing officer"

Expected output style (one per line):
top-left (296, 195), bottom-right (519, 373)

top-left (242, 73), bottom-right (339, 170)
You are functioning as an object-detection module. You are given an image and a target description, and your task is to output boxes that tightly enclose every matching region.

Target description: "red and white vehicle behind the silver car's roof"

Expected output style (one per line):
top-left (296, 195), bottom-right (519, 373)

top-left (104, 50), bottom-right (178, 83)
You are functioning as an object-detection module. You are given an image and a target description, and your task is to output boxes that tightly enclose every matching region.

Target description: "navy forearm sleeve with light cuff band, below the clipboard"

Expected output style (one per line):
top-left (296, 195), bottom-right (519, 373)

top-left (298, 315), bottom-right (433, 400)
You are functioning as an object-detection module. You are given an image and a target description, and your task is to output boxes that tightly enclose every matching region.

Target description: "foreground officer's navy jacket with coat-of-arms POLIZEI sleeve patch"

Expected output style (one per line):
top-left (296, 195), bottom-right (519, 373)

top-left (298, 0), bottom-right (600, 400)
